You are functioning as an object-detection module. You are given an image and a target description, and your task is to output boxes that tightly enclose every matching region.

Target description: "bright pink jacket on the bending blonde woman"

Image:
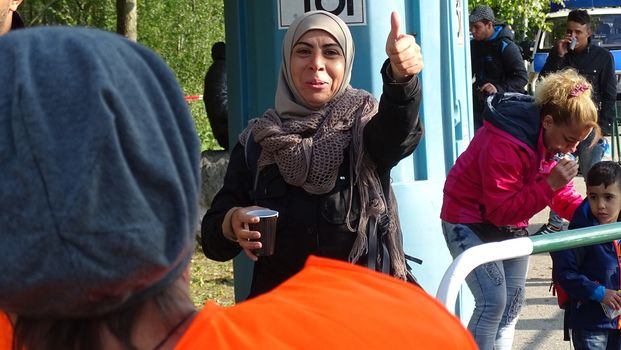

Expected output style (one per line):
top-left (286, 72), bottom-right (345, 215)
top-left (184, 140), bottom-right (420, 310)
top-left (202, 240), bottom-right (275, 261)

top-left (440, 95), bottom-right (582, 227)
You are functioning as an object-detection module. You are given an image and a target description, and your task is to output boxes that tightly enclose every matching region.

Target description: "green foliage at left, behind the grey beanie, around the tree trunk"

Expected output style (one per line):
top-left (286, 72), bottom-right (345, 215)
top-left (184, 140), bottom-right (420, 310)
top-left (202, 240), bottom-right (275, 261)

top-left (19, 0), bottom-right (224, 149)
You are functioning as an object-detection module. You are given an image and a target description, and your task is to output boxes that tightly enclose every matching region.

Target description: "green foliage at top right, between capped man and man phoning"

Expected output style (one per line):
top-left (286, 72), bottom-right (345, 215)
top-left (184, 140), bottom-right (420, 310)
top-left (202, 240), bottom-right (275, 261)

top-left (468, 0), bottom-right (563, 42)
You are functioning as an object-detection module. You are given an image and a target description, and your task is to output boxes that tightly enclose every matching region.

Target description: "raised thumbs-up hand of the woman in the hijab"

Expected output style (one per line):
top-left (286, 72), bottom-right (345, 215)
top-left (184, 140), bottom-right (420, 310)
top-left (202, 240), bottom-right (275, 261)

top-left (386, 11), bottom-right (423, 82)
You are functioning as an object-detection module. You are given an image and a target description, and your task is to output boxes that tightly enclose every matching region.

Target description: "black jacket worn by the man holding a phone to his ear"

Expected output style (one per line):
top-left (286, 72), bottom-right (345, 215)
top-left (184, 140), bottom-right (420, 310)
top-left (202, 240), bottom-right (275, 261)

top-left (539, 44), bottom-right (617, 135)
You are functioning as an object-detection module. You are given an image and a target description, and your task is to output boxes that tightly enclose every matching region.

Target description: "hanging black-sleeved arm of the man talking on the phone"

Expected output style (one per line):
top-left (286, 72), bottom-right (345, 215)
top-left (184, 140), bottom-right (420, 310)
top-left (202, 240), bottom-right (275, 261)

top-left (599, 52), bottom-right (617, 135)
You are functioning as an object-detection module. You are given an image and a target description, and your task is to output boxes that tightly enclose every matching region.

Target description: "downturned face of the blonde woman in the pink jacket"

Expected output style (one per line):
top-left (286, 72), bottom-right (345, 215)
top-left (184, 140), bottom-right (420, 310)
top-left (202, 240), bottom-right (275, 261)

top-left (543, 115), bottom-right (593, 154)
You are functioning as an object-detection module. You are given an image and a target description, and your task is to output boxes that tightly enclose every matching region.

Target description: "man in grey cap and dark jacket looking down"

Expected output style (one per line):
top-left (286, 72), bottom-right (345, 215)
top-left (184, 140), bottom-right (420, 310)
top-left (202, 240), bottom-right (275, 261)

top-left (469, 5), bottom-right (528, 130)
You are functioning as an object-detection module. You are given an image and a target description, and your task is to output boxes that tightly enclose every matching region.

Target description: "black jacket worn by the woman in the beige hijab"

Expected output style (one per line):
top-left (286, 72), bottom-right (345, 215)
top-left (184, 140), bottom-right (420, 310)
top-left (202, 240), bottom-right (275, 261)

top-left (201, 58), bottom-right (423, 296)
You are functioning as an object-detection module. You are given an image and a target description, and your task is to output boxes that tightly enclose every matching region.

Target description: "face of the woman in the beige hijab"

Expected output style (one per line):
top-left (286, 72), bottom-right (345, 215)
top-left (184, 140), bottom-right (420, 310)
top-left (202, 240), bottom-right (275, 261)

top-left (291, 30), bottom-right (345, 108)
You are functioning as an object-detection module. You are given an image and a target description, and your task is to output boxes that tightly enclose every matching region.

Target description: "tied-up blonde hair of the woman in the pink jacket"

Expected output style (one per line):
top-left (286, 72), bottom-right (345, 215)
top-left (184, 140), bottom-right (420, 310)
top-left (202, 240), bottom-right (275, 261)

top-left (535, 68), bottom-right (601, 140)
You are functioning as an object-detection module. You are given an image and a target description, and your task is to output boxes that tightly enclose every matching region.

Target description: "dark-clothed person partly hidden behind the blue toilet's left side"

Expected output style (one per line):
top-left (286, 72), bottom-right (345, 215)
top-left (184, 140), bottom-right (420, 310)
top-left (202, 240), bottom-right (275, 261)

top-left (203, 41), bottom-right (229, 150)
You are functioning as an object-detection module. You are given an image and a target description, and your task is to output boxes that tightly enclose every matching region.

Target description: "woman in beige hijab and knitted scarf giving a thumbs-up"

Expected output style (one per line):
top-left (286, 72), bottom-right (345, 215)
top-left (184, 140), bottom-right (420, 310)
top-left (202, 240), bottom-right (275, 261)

top-left (201, 11), bottom-right (423, 297)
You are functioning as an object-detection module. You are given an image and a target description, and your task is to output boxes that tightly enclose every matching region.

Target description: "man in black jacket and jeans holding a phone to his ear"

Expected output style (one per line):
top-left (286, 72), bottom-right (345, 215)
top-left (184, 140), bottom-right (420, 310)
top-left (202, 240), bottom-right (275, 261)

top-left (537, 10), bottom-right (617, 233)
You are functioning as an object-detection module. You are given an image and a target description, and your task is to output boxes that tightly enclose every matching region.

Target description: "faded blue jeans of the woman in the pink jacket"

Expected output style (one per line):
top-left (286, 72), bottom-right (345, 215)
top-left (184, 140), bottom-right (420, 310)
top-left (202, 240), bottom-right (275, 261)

top-left (442, 221), bottom-right (528, 350)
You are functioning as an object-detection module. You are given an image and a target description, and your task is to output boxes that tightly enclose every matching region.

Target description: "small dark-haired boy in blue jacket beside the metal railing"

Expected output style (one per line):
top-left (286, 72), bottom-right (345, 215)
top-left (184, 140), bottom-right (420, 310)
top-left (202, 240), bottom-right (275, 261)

top-left (551, 161), bottom-right (621, 350)
